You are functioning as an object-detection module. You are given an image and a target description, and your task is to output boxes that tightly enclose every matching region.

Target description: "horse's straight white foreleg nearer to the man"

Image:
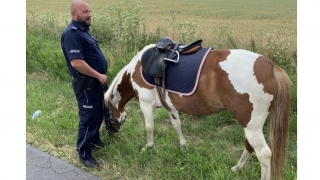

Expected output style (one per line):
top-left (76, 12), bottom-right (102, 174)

top-left (140, 101), bottom-right (154, 150)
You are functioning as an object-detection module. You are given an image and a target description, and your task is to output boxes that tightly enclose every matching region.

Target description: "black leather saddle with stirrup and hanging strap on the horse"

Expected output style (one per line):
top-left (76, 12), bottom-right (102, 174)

top-left (141, 37), bottom-right (202, 111)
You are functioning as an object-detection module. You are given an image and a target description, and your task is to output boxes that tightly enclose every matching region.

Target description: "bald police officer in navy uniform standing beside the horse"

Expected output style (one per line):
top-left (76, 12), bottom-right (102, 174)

top-left (61, 0), bottom-right (107, 167)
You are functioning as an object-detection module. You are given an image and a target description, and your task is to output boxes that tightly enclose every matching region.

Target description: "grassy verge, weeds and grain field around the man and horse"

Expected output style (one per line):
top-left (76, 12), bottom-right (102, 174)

top-left (26, 0), bottom-right (297, 180)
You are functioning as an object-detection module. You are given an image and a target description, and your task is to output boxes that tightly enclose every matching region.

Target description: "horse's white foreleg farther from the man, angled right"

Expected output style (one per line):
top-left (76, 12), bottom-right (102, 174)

top-left (167, 110), bottom-right (188, 149)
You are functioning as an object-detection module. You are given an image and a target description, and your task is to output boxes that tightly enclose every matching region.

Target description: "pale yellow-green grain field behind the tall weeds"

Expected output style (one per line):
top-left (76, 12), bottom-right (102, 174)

top-left (27, 0), bottom-right (297, 53)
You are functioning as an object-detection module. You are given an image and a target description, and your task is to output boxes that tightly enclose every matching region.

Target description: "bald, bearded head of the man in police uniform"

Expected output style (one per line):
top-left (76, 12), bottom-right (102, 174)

top-left (70, 0), bottom-right (91, 27)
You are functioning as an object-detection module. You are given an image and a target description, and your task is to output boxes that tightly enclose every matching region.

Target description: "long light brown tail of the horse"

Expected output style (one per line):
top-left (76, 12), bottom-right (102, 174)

top-left (269, 66), bottom-right (291, 179)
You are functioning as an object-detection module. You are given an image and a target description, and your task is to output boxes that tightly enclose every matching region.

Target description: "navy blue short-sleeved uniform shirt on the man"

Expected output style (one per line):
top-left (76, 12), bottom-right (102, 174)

top-left (61, 20), bottom-right (108, 76)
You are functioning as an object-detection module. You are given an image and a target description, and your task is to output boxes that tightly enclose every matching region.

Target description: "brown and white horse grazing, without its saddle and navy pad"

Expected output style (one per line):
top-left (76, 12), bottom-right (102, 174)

top-left (104, 44), bottom-right (291, 180)
